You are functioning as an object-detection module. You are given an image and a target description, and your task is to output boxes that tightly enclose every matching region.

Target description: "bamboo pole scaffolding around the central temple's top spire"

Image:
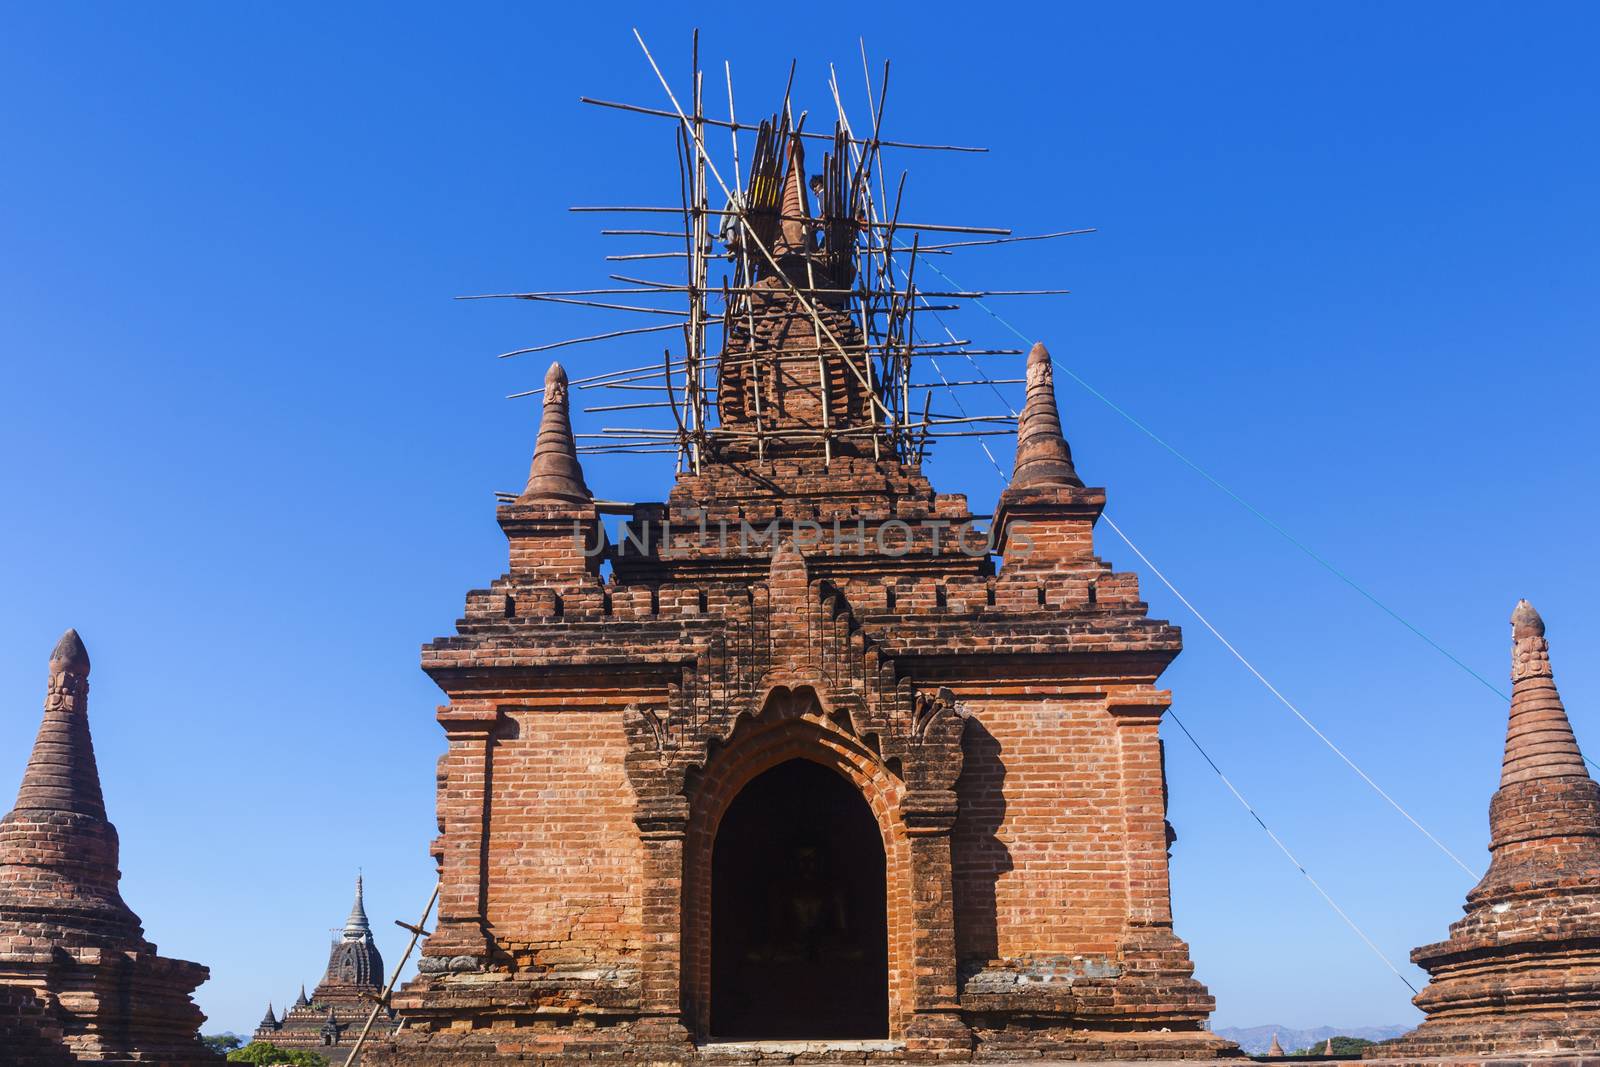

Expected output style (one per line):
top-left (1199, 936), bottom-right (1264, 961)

top-left (483, 30), bottom-right (1062, 472)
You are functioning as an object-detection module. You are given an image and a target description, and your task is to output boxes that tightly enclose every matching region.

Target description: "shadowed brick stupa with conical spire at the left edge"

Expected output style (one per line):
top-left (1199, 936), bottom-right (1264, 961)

top-left (0, 630), bottom-right (222, 1067)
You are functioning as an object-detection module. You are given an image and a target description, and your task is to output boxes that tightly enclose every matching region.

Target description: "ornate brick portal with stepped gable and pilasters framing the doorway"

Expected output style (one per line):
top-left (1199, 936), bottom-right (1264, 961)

top-left (622, 545), bottom-right (973, 1056)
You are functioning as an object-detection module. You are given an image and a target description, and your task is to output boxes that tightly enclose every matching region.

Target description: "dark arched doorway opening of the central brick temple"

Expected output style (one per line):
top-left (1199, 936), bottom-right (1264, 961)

top-left (710, 760), bottom-right (888, 1038)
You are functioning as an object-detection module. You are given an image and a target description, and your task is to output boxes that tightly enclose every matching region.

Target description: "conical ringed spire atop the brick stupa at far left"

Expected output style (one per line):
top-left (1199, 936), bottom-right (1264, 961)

top-left (16, 630), bottom-right (106, 819)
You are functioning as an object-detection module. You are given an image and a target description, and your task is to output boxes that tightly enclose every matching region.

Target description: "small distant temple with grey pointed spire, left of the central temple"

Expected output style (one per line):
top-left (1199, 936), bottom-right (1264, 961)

top-left (250, 875), bottom-right (394, 1067)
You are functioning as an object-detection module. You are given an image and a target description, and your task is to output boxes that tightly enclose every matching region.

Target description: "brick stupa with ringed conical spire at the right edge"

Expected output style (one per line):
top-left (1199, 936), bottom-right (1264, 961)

top-left (1373, 600), bottom-right (1600, 1057)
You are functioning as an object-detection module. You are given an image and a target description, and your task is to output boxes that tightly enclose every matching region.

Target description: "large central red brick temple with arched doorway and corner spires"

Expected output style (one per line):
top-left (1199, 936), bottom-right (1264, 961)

top-left (380, 116), bottom-right (1232, 1064)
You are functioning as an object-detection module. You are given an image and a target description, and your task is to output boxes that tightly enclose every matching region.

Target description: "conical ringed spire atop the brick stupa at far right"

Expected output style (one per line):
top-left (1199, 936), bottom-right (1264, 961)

top-left (1501, 600), bottom-right (1589, 787)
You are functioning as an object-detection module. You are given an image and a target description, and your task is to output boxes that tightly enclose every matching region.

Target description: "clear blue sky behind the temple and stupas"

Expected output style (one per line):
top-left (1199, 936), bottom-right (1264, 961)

top-left (0, 3), bottom-right (1600, 1030)
